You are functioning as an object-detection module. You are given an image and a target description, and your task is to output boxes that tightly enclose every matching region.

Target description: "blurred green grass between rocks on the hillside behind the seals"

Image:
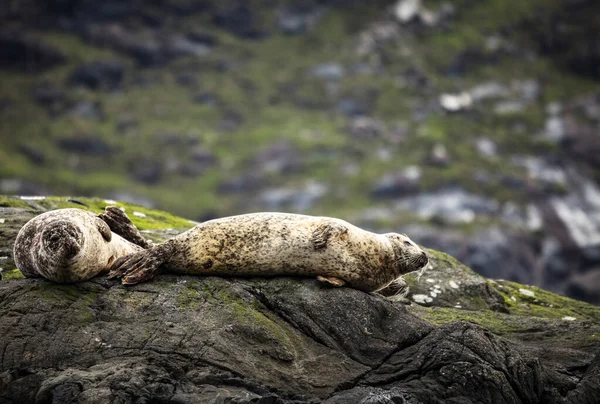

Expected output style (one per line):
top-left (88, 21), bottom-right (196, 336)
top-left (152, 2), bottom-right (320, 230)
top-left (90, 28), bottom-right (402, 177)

top-left (0, 0), bottom-right (598, 223)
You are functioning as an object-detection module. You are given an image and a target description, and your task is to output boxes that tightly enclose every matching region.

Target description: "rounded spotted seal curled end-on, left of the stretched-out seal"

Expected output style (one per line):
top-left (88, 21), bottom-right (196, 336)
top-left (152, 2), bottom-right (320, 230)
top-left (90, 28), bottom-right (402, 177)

top-left (13, 206), bottom-right (147, 283)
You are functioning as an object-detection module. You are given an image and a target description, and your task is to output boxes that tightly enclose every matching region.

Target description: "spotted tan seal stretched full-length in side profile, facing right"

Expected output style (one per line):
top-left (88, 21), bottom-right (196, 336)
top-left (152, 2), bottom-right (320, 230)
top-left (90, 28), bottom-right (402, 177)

top-left (109, 212), bottom-right (428, 292)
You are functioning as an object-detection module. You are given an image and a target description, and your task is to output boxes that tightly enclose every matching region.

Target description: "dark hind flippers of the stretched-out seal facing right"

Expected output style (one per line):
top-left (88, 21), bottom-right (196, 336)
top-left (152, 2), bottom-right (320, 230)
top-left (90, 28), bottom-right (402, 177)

top-left (108, 248), bottom-right (164, 285)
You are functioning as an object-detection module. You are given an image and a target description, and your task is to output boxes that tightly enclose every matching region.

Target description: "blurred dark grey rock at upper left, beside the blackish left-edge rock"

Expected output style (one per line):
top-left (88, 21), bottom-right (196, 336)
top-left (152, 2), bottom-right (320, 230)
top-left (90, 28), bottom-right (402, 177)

top-left (68, 60), bottom-right (125, 90)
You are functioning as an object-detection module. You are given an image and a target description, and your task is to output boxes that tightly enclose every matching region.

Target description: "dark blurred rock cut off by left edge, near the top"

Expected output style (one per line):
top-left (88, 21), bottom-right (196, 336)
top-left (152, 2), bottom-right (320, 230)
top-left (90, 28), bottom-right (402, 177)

top-left (0, 33), bottom-right (66, 73)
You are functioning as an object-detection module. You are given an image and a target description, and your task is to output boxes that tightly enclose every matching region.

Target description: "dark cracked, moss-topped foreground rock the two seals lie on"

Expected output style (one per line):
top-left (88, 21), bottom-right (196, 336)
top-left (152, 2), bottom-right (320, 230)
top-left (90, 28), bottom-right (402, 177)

top-left (0, 198), bottom-right (600, 404)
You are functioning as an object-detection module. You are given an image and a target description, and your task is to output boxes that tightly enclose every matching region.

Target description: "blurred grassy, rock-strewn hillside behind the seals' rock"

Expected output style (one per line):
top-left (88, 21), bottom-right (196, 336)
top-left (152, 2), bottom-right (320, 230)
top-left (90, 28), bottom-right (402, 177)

top-left (0, 0), bottom-right (600, 304)
